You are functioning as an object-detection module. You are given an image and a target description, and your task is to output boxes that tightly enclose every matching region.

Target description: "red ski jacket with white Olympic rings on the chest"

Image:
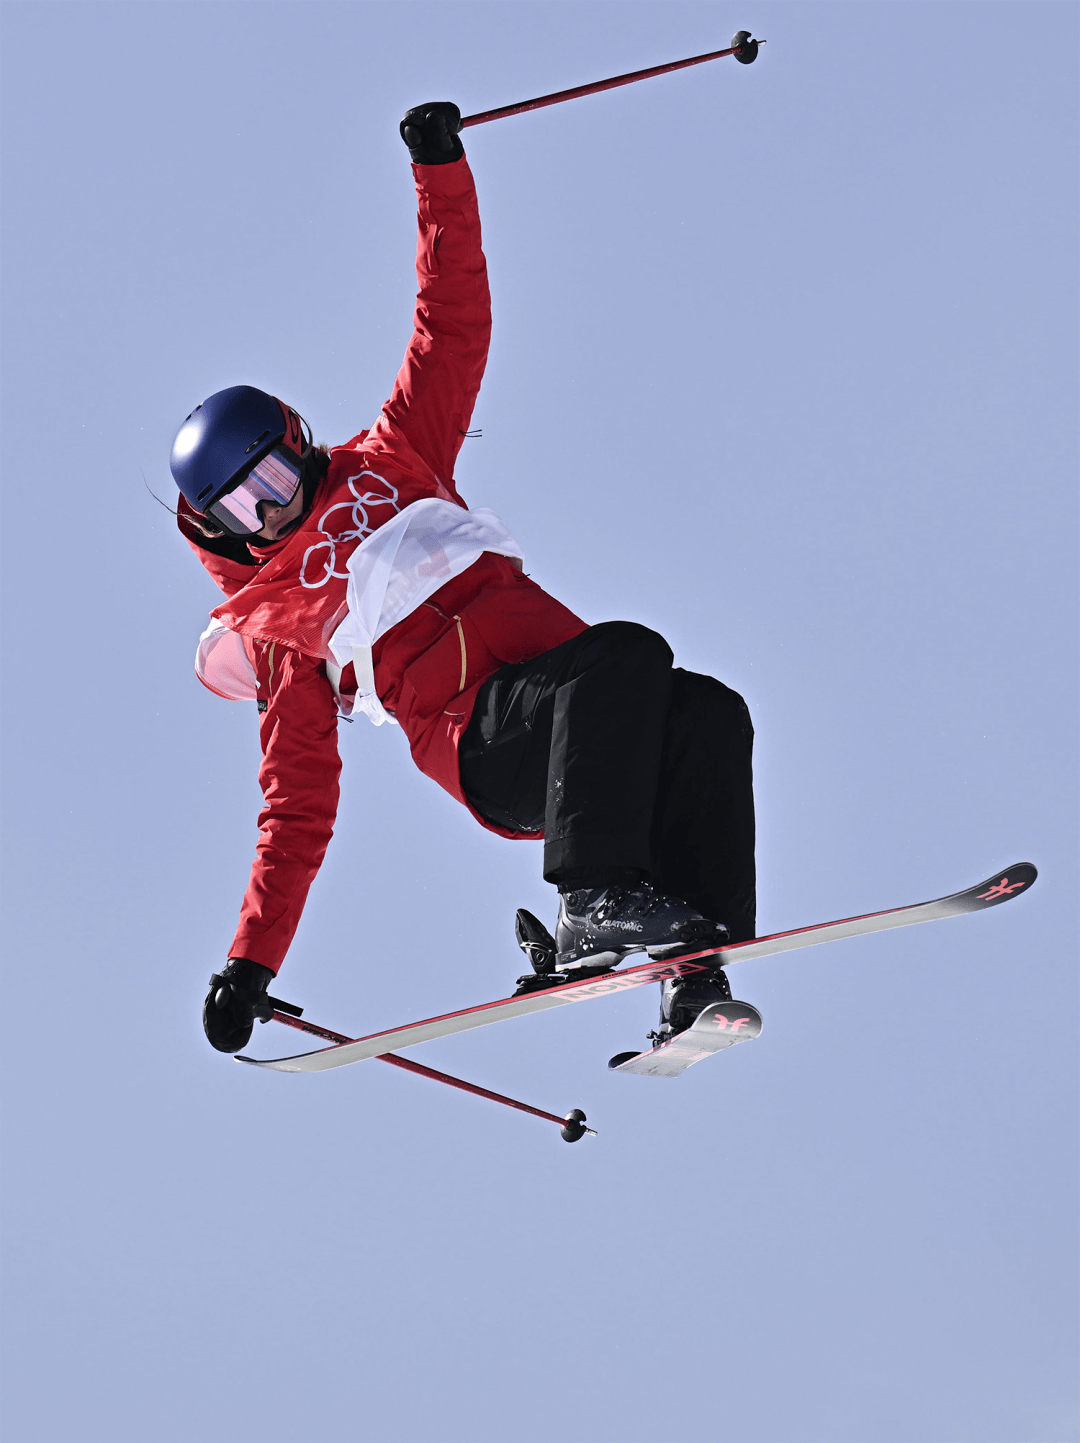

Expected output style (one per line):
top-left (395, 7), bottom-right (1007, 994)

top-left (179, 160), bottom-right (585, 971)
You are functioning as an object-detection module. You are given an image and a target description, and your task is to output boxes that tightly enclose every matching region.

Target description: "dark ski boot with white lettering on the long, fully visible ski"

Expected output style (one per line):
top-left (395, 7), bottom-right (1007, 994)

top-left (554, 882), bottom-right (728, 975)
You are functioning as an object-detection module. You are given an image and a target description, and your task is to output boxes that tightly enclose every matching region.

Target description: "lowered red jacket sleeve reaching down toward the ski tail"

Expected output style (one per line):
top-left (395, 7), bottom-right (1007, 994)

top-left (228, 641), bottom-right (341, 973)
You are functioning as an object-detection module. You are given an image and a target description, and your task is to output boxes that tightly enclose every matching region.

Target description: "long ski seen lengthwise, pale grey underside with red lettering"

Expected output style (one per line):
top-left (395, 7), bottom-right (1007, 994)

top-left (237, 861), bottom-right (1038, 1072)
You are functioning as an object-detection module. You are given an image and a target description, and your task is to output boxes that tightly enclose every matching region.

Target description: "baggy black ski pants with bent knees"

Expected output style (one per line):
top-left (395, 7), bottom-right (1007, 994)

top-left (459, 622), bottom-right (755, 941)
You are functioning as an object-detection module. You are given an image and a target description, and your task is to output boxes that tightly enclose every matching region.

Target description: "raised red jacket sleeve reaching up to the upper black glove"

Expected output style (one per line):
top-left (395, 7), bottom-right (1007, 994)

top-left (370, 159), bottom-right (491, 494)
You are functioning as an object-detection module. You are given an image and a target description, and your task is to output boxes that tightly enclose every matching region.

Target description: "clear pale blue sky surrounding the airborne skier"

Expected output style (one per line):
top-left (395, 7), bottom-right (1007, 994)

top-left (3, 0), bottom-right (1080, 1443)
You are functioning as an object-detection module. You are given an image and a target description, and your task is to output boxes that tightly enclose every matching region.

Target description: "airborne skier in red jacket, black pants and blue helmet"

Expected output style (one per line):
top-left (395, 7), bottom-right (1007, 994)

top-left (170, 102), bottom-right (755, 1052)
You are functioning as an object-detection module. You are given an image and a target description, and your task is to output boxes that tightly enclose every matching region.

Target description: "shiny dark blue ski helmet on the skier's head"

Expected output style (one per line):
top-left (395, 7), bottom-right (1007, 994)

top-left (169, 385), bottom-right (312, 530)
